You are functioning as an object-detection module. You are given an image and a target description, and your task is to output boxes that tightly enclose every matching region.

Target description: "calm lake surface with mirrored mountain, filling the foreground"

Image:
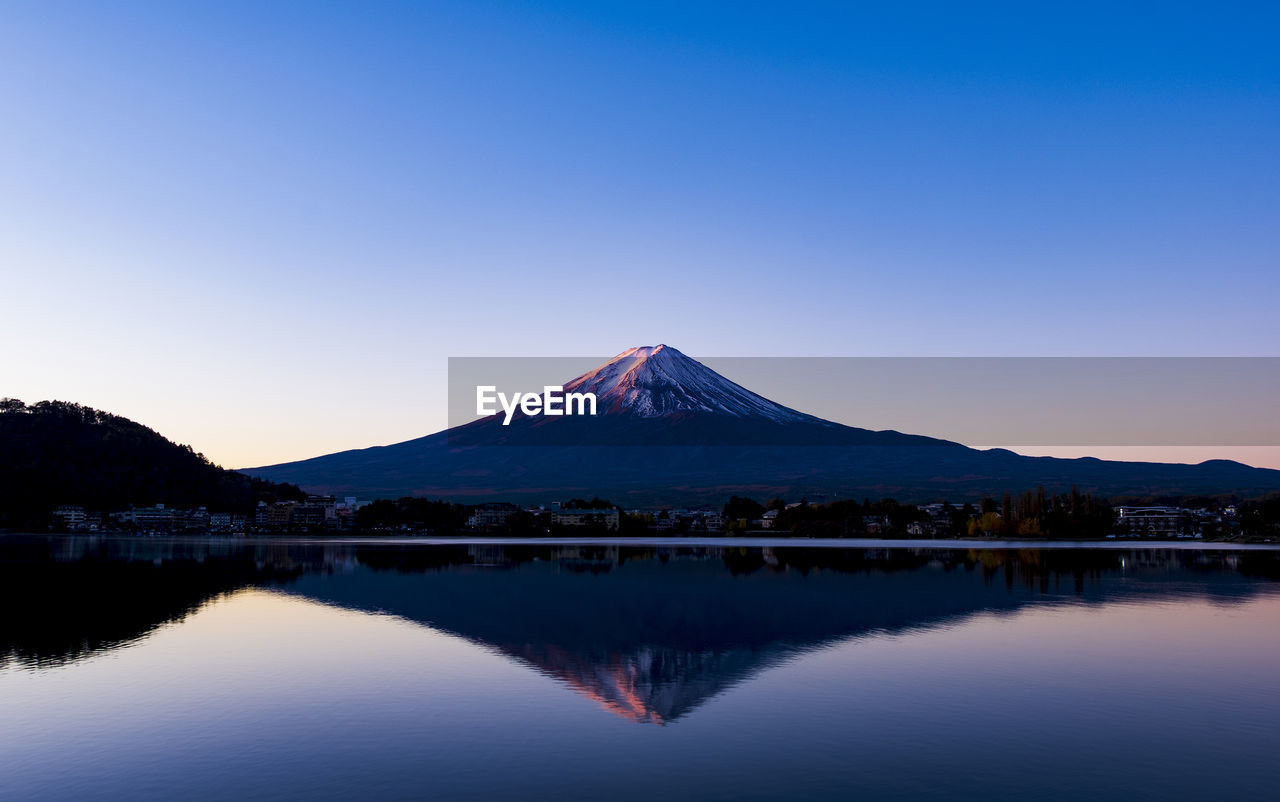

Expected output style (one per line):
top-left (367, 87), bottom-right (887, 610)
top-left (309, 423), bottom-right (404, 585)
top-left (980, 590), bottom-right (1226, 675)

top-left (0, 536), bottom-right (1280, 799)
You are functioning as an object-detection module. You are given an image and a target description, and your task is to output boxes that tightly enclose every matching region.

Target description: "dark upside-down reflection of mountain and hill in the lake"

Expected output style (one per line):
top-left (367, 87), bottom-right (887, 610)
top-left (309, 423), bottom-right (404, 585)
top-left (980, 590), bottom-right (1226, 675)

top-left (0, 536), bottom-right (1280, 724)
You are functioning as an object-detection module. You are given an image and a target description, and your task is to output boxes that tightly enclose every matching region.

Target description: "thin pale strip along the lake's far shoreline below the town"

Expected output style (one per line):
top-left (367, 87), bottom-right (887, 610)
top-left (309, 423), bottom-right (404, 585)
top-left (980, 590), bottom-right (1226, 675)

top-left (10, 531), bottom-right (1280, 551)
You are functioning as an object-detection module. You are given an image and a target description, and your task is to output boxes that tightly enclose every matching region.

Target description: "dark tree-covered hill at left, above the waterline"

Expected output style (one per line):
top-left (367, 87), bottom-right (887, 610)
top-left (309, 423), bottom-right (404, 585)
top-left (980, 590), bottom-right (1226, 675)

top-left (0, 398), bottom-right (305, 528)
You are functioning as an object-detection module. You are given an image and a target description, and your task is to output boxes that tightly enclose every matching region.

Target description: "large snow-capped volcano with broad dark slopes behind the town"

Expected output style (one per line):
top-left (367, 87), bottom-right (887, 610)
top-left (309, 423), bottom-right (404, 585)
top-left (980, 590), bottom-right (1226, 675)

top-left (244, 345), bottom-right (1280, 507)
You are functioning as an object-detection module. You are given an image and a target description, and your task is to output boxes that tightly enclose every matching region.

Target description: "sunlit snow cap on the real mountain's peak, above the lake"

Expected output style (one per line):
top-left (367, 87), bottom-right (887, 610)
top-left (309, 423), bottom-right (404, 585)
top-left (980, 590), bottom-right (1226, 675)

top-left (564, 345), bottom-right (833, 426)
